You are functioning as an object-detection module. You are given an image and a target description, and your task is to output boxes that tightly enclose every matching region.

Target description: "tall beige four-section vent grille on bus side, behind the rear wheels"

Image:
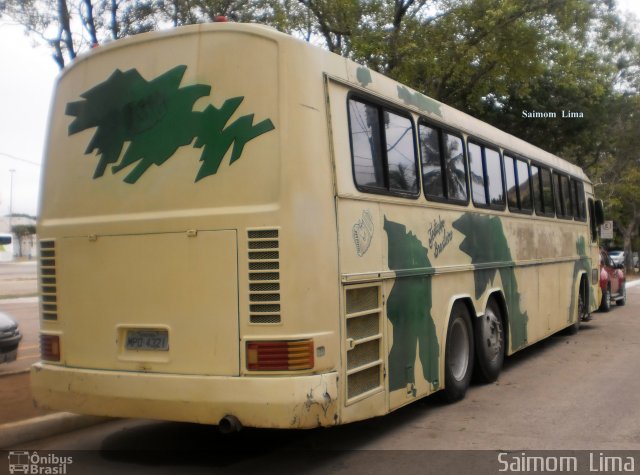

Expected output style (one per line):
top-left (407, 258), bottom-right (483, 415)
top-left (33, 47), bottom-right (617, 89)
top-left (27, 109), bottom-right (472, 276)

top-left (345, 285), bottom-right (383, 404)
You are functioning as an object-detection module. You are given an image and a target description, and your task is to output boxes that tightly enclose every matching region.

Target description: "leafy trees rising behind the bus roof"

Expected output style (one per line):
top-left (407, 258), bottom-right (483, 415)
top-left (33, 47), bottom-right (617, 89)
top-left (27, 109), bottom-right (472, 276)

top-left (5, 0), bottom-right (640, 264)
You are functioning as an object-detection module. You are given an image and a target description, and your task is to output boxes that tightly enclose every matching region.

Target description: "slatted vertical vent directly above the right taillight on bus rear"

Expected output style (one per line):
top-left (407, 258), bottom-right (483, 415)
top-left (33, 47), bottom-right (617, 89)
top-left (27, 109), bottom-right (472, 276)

top-left (247, 229), bottom-right (281, 324)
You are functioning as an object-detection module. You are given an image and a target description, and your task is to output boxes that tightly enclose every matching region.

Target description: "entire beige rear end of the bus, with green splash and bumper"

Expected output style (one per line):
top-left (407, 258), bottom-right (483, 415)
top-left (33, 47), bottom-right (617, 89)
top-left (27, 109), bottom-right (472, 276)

top-left (32, 24), bottom-right (340, 428)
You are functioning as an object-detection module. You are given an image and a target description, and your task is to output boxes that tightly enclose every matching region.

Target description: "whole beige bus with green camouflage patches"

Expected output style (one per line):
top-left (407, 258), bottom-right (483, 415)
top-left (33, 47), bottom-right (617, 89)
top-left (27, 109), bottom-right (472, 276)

top-left (32, 23), bottom-right (601, 430)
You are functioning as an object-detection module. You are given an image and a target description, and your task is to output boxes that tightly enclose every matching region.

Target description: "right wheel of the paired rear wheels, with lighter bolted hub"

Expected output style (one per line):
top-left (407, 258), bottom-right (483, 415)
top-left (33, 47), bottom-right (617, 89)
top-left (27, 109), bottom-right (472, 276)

top-left (474, 299), bottom-right (504, 383)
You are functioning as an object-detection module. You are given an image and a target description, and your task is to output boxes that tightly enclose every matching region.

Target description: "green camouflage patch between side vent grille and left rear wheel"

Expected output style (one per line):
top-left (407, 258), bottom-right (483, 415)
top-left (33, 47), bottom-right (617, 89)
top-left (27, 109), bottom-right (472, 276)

top-left (384, 217), bottom-right (440, 391)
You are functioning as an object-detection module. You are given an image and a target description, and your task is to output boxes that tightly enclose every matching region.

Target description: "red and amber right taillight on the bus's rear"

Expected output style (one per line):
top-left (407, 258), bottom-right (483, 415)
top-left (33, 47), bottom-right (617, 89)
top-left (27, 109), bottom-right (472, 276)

top-left (247, 340), bottom-right (313, 371)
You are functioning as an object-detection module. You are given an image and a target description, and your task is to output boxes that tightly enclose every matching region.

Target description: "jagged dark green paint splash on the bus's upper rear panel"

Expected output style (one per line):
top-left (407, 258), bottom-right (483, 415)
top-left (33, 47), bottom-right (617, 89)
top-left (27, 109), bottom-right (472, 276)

top-left (66, 65), bottom-right (274, 183)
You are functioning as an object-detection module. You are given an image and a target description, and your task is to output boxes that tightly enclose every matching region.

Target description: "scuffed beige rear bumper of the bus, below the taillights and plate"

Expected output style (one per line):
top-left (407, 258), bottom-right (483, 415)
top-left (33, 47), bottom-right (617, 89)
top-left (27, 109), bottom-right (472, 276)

top-left (31, 363), bottom-right (338, 428)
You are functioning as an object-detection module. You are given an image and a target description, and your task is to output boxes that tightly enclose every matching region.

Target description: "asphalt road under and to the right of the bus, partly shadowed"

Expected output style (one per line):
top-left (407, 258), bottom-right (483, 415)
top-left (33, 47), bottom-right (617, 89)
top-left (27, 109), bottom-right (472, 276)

top-left (1, 287), bottom-right (640, 474)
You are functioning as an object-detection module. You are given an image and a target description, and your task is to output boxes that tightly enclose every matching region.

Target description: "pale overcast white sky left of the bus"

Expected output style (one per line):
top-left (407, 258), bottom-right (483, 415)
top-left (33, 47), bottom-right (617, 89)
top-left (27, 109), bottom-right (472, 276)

top-left (0, 0), bottom-right (640, 216)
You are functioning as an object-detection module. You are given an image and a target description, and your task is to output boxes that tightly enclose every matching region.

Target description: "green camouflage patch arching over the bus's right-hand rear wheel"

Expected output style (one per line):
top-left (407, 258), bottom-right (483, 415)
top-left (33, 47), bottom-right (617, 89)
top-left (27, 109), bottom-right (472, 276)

top-left (453, 213), bottom-right (529, 350)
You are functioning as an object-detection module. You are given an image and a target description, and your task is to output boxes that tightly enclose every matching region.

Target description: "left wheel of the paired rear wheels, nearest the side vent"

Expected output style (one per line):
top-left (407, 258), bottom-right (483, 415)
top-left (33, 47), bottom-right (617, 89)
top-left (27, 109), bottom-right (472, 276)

top-left (442, 302), bottom-right (474, 402)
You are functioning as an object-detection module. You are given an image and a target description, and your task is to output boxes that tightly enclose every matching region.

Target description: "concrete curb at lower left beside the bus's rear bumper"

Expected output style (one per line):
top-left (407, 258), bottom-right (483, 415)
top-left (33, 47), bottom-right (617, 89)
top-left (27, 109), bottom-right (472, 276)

top-left (0, 412), bottom-right (115, 449)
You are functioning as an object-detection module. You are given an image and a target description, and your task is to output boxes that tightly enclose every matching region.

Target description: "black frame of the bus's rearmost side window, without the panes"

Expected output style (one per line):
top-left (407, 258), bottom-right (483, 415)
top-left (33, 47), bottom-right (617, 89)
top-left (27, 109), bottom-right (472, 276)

top-left (346, 91), bottom-right (422, 200)
